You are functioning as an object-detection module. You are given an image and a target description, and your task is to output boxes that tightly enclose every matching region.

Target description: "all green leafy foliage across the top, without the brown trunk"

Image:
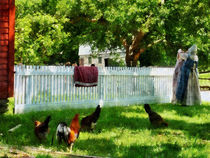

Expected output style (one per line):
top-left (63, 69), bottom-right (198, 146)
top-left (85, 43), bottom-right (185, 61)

top-left (15, 0), bottom-right (210, 70)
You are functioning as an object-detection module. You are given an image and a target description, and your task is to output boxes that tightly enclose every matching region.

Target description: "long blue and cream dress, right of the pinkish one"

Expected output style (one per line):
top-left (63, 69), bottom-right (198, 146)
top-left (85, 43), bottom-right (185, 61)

top-left (176, 45), bottom-right (201, 106)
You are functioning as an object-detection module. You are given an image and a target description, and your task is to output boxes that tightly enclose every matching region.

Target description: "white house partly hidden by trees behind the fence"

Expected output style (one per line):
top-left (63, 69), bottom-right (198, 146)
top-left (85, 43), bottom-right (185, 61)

top-left (79, 45), bottom-right (125, 67)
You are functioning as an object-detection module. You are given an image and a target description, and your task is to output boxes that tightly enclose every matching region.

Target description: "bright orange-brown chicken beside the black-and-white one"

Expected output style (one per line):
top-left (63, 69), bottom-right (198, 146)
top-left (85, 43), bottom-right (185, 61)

top-left (68, 114), bottom-right (80, 152)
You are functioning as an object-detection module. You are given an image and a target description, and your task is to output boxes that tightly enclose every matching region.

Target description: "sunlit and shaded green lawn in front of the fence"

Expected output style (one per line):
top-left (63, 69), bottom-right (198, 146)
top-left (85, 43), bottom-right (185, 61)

top-left (0, 103), bottom-right (210, 158)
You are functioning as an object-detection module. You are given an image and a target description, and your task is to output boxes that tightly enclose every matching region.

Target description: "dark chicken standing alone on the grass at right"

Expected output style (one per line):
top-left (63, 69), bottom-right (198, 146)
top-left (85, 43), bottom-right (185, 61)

top-left (144, 104), bottom-right (168, 127)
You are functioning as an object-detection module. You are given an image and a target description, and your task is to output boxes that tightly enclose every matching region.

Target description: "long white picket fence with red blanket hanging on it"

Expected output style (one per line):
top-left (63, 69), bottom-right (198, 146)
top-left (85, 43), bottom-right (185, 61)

top-left (14, 66), bottom-right (174, 113)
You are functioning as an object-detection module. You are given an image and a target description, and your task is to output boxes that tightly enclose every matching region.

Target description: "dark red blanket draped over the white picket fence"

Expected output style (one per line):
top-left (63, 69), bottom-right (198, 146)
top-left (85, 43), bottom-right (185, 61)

top-left (74, 66), bottom-right (98, 87)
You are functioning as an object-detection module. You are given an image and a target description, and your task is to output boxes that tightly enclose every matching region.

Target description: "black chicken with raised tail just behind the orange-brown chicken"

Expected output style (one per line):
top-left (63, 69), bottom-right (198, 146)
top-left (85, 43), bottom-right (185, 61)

top-left (81, 105), bottom-right (101, 131)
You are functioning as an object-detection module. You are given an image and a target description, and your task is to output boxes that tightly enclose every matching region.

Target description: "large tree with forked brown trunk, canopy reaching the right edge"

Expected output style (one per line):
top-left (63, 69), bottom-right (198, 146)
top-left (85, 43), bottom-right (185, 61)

top-left (57, 0), bottom-right (209, 66)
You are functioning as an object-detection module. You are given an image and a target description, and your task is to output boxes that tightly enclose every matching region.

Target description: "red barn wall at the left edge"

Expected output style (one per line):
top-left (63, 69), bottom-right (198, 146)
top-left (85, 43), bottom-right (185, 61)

top-left (0, 0), bottom-right (15, 99)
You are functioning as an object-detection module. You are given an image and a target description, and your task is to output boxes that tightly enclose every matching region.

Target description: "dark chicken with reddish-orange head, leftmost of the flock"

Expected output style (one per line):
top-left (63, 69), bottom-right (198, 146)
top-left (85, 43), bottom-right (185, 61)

top-left (34, 116), bottom-right (51, 142)
